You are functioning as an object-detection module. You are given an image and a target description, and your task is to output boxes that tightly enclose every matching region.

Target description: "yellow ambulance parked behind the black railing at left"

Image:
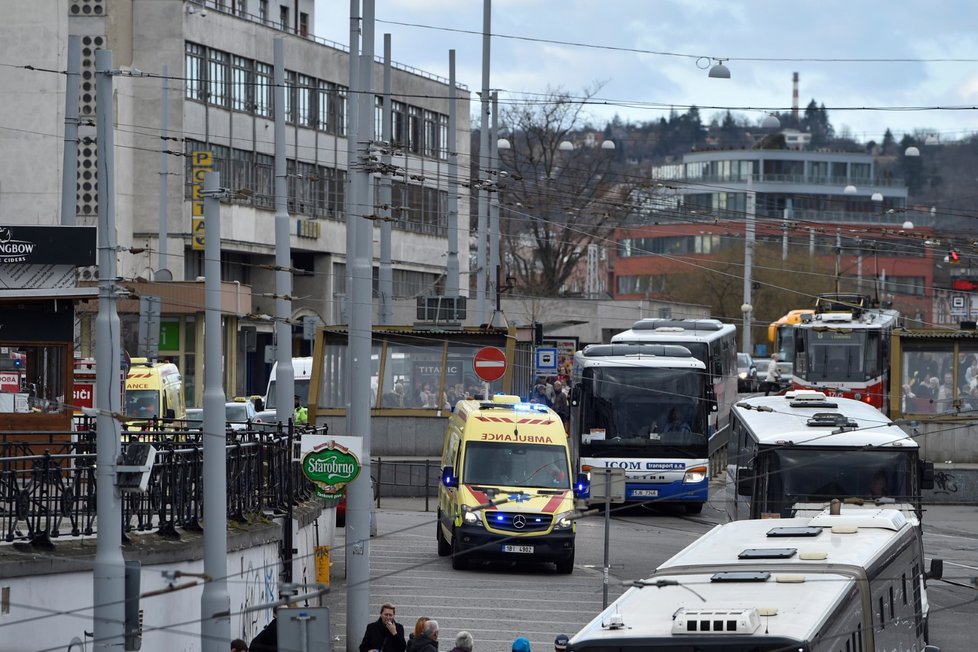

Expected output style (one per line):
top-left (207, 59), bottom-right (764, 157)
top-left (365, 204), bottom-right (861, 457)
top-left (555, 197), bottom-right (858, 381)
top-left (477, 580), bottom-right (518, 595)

top-left (123, 358), bottom-right (187, 425)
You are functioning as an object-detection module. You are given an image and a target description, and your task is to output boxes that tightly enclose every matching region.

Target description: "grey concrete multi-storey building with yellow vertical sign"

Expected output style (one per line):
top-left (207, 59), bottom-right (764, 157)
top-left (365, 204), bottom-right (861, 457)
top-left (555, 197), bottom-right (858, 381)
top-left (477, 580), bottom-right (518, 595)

top-left (0, 0), bottom-right (470, 401)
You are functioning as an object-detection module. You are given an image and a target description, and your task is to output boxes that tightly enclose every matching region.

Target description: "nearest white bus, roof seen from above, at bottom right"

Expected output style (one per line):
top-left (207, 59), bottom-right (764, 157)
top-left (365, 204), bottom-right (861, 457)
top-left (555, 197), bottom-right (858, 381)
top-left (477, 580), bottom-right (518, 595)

top-left (567, 507), bottom-right (941, 652)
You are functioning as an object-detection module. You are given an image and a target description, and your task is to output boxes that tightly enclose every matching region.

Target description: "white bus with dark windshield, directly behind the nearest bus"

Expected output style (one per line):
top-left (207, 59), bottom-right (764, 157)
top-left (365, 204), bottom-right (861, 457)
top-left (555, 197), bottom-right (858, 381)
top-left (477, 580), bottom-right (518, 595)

top-left (726, 390), bottom-right (934, 522)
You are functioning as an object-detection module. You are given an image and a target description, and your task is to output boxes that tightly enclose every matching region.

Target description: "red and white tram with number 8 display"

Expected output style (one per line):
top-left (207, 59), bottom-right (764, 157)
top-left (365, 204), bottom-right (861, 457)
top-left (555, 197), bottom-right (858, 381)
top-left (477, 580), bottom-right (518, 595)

top-left (791, 294), bottom-right (900, 414)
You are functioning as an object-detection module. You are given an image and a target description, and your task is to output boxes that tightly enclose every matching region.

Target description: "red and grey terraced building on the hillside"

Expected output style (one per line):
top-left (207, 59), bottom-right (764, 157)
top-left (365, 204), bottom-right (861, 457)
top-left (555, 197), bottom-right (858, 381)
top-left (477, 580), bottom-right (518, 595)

top-left (611, 149), bottom-right (935, 336)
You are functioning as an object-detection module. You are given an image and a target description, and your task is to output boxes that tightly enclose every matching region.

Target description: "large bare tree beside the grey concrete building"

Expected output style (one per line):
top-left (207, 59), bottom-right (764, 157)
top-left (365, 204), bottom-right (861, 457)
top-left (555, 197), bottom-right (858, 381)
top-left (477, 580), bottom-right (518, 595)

top-left (488, 88), bottom-right (629, 296)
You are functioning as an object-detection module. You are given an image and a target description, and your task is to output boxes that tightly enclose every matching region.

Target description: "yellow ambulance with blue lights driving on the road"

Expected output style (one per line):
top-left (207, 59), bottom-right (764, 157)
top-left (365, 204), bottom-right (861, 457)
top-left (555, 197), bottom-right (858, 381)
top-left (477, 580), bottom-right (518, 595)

top-left (437, 395), bottom-right (588, 573)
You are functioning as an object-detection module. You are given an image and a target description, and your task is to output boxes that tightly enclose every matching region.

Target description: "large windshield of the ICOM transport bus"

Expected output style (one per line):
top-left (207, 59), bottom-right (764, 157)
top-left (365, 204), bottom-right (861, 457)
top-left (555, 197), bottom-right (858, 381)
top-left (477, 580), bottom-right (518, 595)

top-left (580, 366), bottom-right (708, 457)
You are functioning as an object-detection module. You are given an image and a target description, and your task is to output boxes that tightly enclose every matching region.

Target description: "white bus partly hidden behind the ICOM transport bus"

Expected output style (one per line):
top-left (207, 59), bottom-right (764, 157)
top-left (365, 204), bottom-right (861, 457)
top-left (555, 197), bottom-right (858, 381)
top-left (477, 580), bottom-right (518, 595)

top-left (611, 319), bottom-right (737, 471)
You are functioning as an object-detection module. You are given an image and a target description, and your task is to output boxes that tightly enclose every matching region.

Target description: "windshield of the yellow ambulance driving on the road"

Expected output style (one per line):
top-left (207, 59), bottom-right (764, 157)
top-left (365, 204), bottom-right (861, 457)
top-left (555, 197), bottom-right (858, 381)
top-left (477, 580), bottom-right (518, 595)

top-left (459, 441), bottom-right (570, 489)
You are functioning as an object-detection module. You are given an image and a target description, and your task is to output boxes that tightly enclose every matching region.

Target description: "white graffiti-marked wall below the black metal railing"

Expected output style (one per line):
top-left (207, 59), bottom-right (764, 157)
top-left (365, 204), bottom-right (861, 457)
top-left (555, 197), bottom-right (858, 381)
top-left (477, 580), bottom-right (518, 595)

top-left (0, 506), bottom-right (341, 652)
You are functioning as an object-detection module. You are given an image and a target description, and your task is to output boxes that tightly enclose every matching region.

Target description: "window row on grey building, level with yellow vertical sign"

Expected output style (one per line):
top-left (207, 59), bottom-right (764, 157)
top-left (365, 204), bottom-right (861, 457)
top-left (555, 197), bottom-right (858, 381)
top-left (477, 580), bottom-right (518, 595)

top-left (185, 140), bottom-right (448, 237)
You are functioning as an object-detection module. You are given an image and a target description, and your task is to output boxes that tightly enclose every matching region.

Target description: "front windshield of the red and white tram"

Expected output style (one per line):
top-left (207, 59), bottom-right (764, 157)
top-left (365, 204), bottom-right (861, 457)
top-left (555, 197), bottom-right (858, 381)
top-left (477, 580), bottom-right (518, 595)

top-left (795, 329), bottom-right (878, 382)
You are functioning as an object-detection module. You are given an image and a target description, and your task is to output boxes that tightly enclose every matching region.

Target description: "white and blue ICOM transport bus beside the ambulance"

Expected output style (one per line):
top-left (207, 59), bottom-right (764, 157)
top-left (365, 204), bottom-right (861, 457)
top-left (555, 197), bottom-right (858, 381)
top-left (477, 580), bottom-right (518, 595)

top-left (570, 343), bottom-right (716, 514)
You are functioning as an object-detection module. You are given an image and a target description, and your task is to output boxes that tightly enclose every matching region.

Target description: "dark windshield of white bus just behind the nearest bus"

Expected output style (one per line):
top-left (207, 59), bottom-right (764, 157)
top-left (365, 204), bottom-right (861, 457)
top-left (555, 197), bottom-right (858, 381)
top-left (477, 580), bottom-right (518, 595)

top-left (756, 448), bottom-right (920, 517)
